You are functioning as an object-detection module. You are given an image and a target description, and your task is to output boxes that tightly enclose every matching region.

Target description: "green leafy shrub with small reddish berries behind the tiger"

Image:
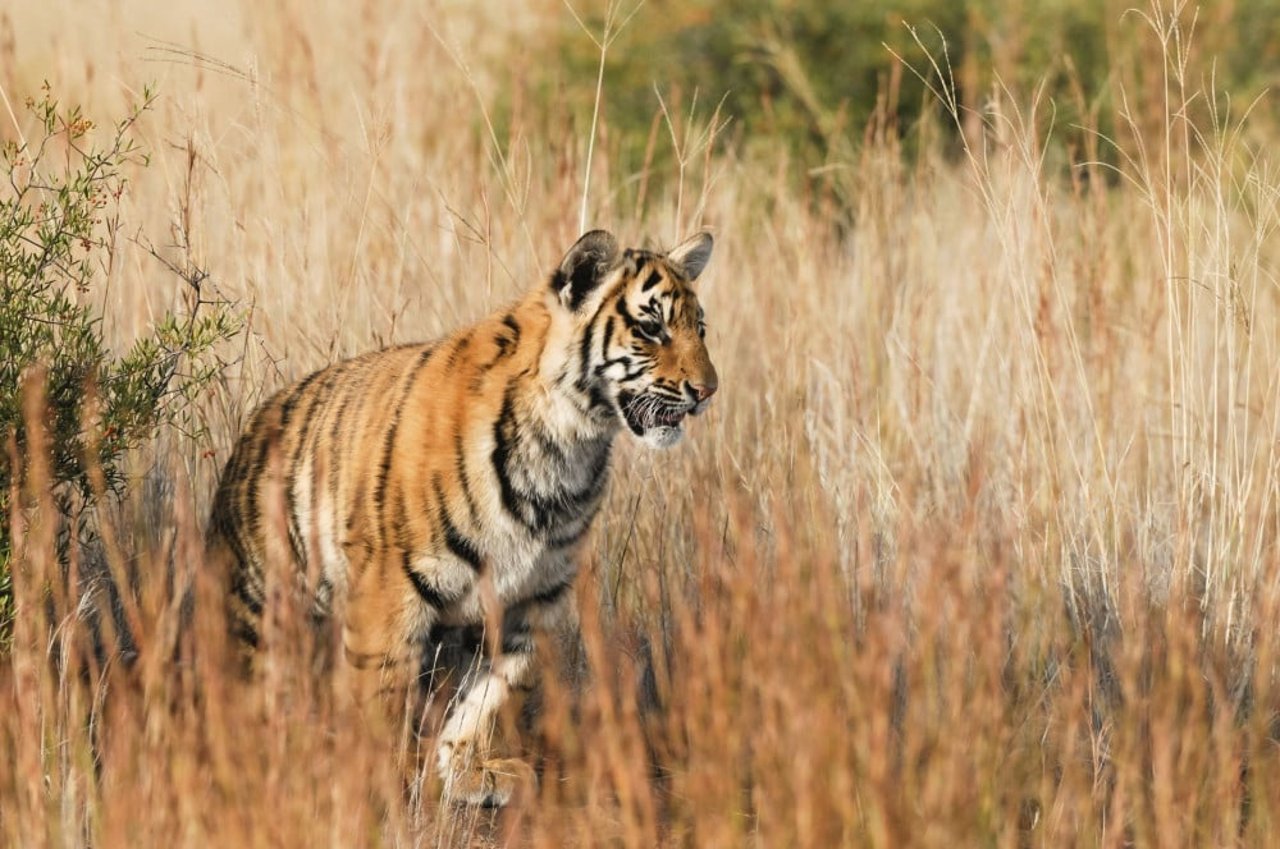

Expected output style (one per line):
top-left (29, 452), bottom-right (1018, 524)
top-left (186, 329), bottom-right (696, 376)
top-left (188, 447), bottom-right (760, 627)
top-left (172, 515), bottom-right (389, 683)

top-left (0, 85), bottom-right (239, 645)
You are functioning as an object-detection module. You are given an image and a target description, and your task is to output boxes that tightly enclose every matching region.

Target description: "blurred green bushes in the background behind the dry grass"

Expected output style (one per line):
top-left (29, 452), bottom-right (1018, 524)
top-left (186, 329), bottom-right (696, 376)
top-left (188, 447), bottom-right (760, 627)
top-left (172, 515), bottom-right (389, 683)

top-left (521, 0), bottom-right (1280, 179)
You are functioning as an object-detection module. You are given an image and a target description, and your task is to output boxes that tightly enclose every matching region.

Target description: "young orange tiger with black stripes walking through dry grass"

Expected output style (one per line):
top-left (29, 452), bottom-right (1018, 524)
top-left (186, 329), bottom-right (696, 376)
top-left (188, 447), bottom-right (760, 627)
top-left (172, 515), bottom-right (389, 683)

top-left (207, 229), bottom-right (718, 807)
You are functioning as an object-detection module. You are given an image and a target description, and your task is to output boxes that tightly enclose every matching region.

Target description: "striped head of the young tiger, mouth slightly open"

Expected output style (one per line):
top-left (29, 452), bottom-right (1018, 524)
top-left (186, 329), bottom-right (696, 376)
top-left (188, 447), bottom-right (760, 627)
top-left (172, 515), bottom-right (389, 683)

top-left (552, 230), bottom-right (719, 448)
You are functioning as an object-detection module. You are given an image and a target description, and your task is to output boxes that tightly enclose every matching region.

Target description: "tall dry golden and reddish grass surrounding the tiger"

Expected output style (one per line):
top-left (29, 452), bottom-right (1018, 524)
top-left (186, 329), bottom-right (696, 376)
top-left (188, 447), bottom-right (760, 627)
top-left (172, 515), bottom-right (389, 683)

top-left (0, 0), bottom-right (1280, 849)
